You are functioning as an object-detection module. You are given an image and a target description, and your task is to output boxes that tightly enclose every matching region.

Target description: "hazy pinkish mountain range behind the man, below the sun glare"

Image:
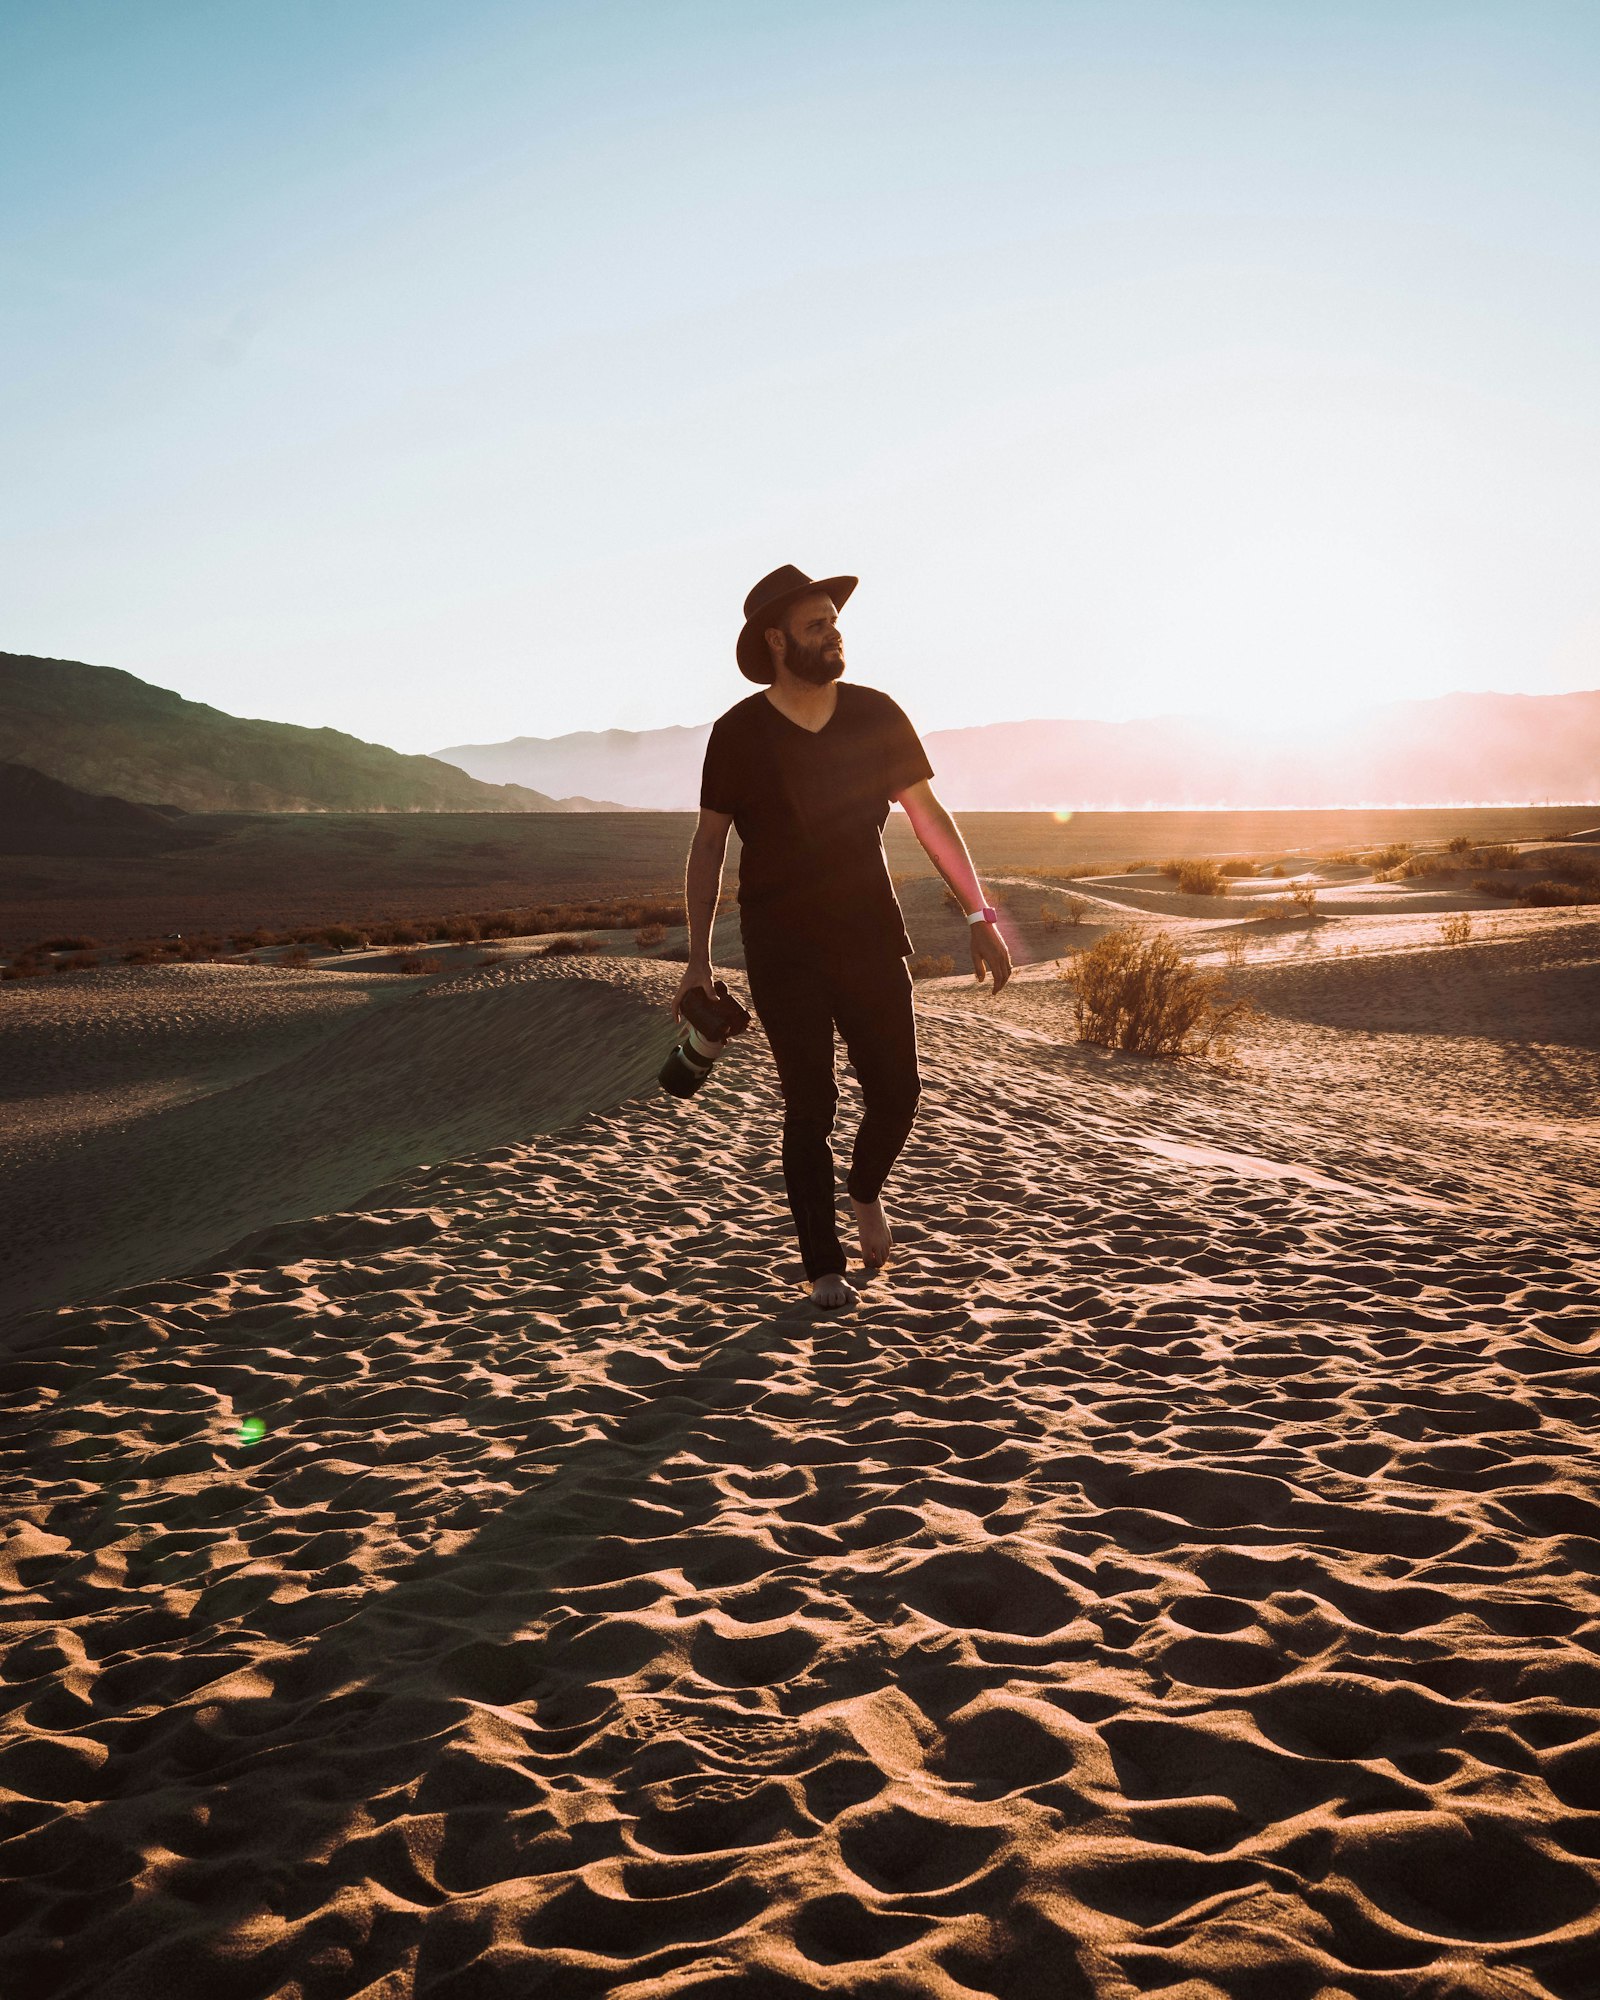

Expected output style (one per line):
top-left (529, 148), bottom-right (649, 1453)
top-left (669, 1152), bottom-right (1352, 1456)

top-left (438, 692), bottom-right (1600, 812)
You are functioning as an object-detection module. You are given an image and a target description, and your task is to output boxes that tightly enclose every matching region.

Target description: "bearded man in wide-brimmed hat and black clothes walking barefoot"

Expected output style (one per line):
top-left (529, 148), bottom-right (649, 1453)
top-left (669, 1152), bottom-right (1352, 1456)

top-left (672, 564), bottom-right (1012, 1310)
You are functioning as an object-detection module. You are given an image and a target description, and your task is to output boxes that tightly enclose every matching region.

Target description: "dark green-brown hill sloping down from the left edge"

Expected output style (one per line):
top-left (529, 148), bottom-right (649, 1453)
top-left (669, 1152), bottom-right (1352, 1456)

top-left (0, 652), bottom-right (618, 812)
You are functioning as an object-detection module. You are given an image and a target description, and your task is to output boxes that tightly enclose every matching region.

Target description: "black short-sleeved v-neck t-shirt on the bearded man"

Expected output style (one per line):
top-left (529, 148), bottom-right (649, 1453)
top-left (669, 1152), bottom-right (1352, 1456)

top-left (700, 680), bottom-right (934, 958)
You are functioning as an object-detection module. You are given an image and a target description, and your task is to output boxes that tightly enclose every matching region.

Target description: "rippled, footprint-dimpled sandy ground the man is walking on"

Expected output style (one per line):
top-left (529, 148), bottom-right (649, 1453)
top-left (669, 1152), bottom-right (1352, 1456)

top-left (0, 898), bottom-right (1600, 2000)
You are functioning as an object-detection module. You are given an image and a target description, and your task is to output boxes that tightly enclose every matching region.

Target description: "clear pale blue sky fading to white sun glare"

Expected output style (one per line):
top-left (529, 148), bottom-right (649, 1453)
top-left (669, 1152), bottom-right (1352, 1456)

top-left (0, 0), bottom-right (1600, 750)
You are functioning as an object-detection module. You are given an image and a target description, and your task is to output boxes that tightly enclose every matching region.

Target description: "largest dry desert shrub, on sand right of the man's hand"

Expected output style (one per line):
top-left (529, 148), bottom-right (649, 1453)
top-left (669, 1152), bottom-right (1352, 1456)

top-left (1066, 928), bottom-right (1254, 1056)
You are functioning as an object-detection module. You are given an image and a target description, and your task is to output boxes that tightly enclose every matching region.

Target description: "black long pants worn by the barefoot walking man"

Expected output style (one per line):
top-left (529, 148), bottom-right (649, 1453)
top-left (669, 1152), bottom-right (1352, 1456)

top-left (746, 946), bottom-right (922, 1278)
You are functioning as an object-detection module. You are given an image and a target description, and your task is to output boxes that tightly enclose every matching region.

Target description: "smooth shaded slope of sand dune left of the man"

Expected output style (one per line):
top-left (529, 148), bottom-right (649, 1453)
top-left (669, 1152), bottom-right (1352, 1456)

top-left (0, 958), bottom-right (672, 1324)
